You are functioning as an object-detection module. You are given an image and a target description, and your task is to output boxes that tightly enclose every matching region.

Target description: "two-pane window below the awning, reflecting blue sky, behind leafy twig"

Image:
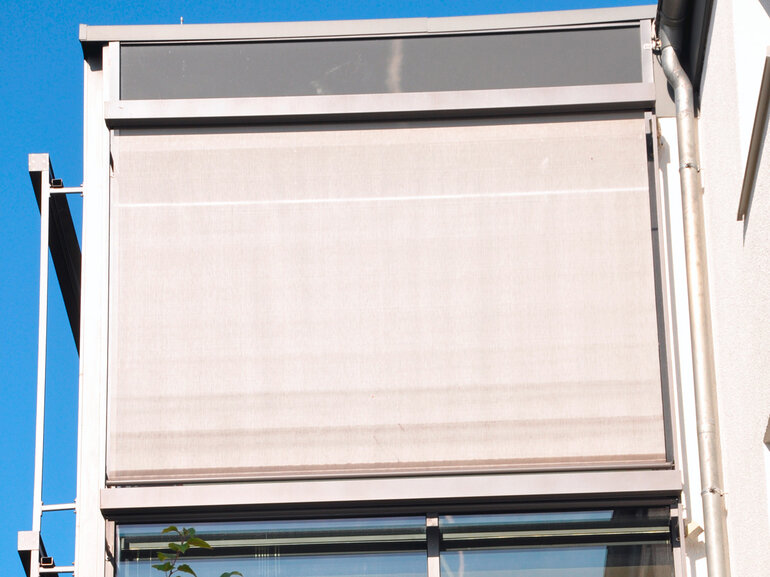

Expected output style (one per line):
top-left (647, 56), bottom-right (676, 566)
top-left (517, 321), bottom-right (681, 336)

top-left (118, 507), bottom-right (673, 577)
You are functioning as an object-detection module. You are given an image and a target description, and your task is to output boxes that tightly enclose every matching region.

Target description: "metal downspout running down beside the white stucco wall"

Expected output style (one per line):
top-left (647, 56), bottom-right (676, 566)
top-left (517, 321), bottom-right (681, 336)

top-left (659, 0), bottom-right (730, 577)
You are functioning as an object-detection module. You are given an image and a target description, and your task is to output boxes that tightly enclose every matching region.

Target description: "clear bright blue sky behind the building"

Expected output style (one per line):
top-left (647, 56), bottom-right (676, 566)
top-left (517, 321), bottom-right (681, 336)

top-left (0, 0), bottom-right (651, 577)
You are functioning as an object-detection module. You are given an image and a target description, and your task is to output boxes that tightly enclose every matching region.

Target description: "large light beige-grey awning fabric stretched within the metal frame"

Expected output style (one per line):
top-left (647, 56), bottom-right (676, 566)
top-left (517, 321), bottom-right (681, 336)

top-left (107, 118), bottom-right (665, 482)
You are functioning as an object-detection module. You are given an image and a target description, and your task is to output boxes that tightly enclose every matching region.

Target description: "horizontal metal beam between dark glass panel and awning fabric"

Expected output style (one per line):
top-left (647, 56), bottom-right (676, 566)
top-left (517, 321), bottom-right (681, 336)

top-left (104, 83), bottom-right (655, 128)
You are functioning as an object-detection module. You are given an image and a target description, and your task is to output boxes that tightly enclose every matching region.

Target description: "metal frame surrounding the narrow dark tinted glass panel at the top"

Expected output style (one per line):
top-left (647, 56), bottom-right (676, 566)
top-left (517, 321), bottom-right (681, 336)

top-left (102, 16), bottom-right (656, 128)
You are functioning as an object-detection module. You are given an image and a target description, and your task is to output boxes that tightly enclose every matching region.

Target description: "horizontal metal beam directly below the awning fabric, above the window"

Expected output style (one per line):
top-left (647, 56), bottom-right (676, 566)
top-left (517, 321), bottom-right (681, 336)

top-left (101, 469), bottom-right (682, 516)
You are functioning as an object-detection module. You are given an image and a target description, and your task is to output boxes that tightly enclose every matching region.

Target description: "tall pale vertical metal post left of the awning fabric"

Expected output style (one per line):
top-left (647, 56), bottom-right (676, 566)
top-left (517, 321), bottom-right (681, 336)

top-left (75, 44), bottom-right (117, 577)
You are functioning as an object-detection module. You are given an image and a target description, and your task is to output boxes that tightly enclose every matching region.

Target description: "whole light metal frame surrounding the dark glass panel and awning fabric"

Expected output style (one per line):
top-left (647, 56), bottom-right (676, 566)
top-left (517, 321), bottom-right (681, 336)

top-left (66, 7), bottom-right (682, 577)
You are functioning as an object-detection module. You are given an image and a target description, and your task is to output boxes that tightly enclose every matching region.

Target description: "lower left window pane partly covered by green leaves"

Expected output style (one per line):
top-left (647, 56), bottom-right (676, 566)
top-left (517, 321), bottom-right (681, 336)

top-left (118, 517), bottom-right (427, 577)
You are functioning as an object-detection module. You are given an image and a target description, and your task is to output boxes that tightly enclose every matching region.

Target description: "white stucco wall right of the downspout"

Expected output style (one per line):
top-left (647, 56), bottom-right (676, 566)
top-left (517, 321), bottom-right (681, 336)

top-left (691, 0), bottom-right (770, 576)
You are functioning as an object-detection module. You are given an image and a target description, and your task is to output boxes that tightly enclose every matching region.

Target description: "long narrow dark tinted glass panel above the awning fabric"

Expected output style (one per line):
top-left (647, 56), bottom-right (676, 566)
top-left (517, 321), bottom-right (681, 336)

top-left (121, 26), bottom-right (642, 100)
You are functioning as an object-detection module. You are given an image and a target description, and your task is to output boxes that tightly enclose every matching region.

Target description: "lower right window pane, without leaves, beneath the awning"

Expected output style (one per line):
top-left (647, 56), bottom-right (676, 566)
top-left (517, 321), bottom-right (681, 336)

top-left (439, 508), bottom-right (673, 577)
